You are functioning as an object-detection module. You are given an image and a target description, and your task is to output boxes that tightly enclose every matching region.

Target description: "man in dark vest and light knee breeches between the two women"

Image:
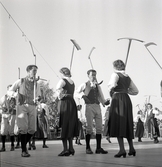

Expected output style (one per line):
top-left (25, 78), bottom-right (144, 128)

top-left (75, 69), bottom-right (108, 154)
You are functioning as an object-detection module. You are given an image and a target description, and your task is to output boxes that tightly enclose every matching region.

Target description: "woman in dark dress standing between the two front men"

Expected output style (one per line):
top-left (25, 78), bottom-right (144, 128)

top-left (56, 67), bottom-right (78, 156)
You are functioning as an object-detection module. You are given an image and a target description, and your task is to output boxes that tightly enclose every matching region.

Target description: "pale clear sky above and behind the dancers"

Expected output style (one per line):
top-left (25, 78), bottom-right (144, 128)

top-left (0, 0), bottom-right (162, 115)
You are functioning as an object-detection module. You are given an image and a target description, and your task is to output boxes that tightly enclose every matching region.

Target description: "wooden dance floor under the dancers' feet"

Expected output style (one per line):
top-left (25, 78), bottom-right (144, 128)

top-left (0, 138), bottom-right (162, 167)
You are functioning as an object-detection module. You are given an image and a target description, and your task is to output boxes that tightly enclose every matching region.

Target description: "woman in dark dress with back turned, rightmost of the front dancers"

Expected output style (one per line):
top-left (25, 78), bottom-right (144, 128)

top-left (108, 60), bottom-right (138, 158)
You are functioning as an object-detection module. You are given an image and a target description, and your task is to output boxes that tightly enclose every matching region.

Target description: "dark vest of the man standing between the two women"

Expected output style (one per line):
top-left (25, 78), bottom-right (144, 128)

top-left (84, 81), bottom-right (100, 104)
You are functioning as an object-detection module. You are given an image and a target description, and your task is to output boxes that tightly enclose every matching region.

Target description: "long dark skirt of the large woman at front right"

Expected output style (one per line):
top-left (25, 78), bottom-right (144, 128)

top-left (108, 93), bottom-right (134, 139)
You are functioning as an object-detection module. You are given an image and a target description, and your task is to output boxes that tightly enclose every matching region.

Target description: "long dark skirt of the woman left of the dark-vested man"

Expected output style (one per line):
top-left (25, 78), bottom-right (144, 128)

top-left (58, 97), bottom-right (79, 139)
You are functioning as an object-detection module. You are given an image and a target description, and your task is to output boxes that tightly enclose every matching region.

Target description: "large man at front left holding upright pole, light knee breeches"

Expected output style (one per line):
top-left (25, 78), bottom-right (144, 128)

top-left (8, 65), bottom-right (41, 157)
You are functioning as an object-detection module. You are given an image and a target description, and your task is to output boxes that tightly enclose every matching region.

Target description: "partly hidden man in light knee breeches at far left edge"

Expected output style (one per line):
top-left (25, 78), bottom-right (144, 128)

top-left (0, 85), bottom-right (16, 152)
